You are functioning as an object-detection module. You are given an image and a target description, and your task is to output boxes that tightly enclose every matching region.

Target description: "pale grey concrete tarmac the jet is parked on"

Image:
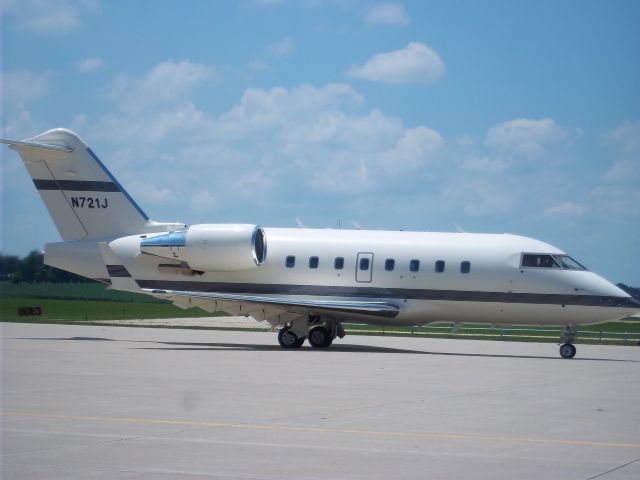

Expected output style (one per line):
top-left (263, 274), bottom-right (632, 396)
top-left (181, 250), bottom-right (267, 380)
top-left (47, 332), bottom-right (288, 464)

top-left (0, 323), bottom-right (640, 480)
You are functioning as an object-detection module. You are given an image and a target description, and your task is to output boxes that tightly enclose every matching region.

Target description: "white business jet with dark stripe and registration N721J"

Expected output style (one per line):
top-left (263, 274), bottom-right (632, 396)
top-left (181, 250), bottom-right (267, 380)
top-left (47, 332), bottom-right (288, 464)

top-left (2, 129), bottom-right (640, 358)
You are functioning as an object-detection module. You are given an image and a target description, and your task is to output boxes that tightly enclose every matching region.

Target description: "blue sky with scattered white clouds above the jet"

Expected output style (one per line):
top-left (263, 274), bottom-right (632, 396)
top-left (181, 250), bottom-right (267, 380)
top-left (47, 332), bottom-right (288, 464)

top-left (1, 0), bottom-right (640, 285)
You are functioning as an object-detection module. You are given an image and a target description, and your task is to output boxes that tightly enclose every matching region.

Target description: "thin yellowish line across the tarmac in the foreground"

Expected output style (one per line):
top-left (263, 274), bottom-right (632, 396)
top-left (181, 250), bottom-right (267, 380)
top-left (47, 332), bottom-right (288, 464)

top-left (0, 412), bottom-right (640, 449)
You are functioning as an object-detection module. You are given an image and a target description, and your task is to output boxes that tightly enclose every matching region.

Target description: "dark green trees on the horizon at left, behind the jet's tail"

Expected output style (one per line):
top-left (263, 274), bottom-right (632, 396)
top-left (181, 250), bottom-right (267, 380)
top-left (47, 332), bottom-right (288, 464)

top-left (0, 250), bottom-right (92, 283)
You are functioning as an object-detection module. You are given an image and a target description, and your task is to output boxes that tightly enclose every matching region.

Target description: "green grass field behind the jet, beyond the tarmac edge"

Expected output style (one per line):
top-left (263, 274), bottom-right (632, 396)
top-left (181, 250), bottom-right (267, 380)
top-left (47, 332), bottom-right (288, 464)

top-left (0, 283), bottom-right (640, 345)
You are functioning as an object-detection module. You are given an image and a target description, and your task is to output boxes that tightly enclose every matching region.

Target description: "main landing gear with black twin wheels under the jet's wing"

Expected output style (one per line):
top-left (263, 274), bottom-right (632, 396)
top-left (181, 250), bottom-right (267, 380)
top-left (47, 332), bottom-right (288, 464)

top-left (278, 315), bottom-right (345, 349)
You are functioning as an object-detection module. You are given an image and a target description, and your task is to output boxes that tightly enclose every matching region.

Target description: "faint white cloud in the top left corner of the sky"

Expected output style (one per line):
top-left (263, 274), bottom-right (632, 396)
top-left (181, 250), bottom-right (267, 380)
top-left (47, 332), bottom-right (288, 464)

top-left (4, 0), bottom-right (100, 35)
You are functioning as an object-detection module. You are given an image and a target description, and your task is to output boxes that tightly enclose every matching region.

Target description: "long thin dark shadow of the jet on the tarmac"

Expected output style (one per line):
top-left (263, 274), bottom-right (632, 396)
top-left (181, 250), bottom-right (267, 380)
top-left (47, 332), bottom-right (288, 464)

top-left (11, 337), bottom-right (640, 363)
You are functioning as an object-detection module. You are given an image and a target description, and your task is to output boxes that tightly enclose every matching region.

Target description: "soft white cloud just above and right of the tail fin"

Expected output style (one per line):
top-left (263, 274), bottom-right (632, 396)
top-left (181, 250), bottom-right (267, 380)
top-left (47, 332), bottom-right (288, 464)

top-left (107, 60), bottom-right (217, 110)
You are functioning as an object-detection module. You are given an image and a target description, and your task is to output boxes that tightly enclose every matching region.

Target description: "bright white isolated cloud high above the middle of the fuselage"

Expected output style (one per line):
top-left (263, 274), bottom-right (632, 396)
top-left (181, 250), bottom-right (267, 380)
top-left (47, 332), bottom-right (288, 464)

top-left (345, 42), bottom-right (445, 84)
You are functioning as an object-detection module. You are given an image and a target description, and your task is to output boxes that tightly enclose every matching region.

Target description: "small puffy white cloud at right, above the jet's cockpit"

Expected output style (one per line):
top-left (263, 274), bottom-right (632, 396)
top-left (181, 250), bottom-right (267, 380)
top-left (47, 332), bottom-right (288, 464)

top-left (485, 118), bottom-right (567, 157)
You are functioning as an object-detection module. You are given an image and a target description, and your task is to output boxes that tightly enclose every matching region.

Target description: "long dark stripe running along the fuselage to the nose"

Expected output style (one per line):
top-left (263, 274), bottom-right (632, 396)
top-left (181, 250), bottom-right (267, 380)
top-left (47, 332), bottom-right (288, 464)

top-left (136, 280), bottom-right (640, 310)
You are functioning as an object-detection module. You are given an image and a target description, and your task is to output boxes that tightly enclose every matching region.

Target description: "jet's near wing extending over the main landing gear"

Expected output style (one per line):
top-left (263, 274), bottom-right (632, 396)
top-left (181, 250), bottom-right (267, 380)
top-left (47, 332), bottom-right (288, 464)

top-left (142, 288), bottom-right (400, 325)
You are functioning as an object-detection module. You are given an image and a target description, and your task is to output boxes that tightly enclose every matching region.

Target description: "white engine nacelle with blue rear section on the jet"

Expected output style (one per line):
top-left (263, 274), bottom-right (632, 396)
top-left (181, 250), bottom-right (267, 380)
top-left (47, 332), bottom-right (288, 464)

top-left (140, 224), bottom-right (267, 272)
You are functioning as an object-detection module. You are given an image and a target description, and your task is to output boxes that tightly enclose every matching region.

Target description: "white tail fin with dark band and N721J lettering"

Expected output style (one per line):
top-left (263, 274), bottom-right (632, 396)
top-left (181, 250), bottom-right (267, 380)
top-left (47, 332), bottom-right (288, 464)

top-left (0, 128), bottom-right (183, 241)
